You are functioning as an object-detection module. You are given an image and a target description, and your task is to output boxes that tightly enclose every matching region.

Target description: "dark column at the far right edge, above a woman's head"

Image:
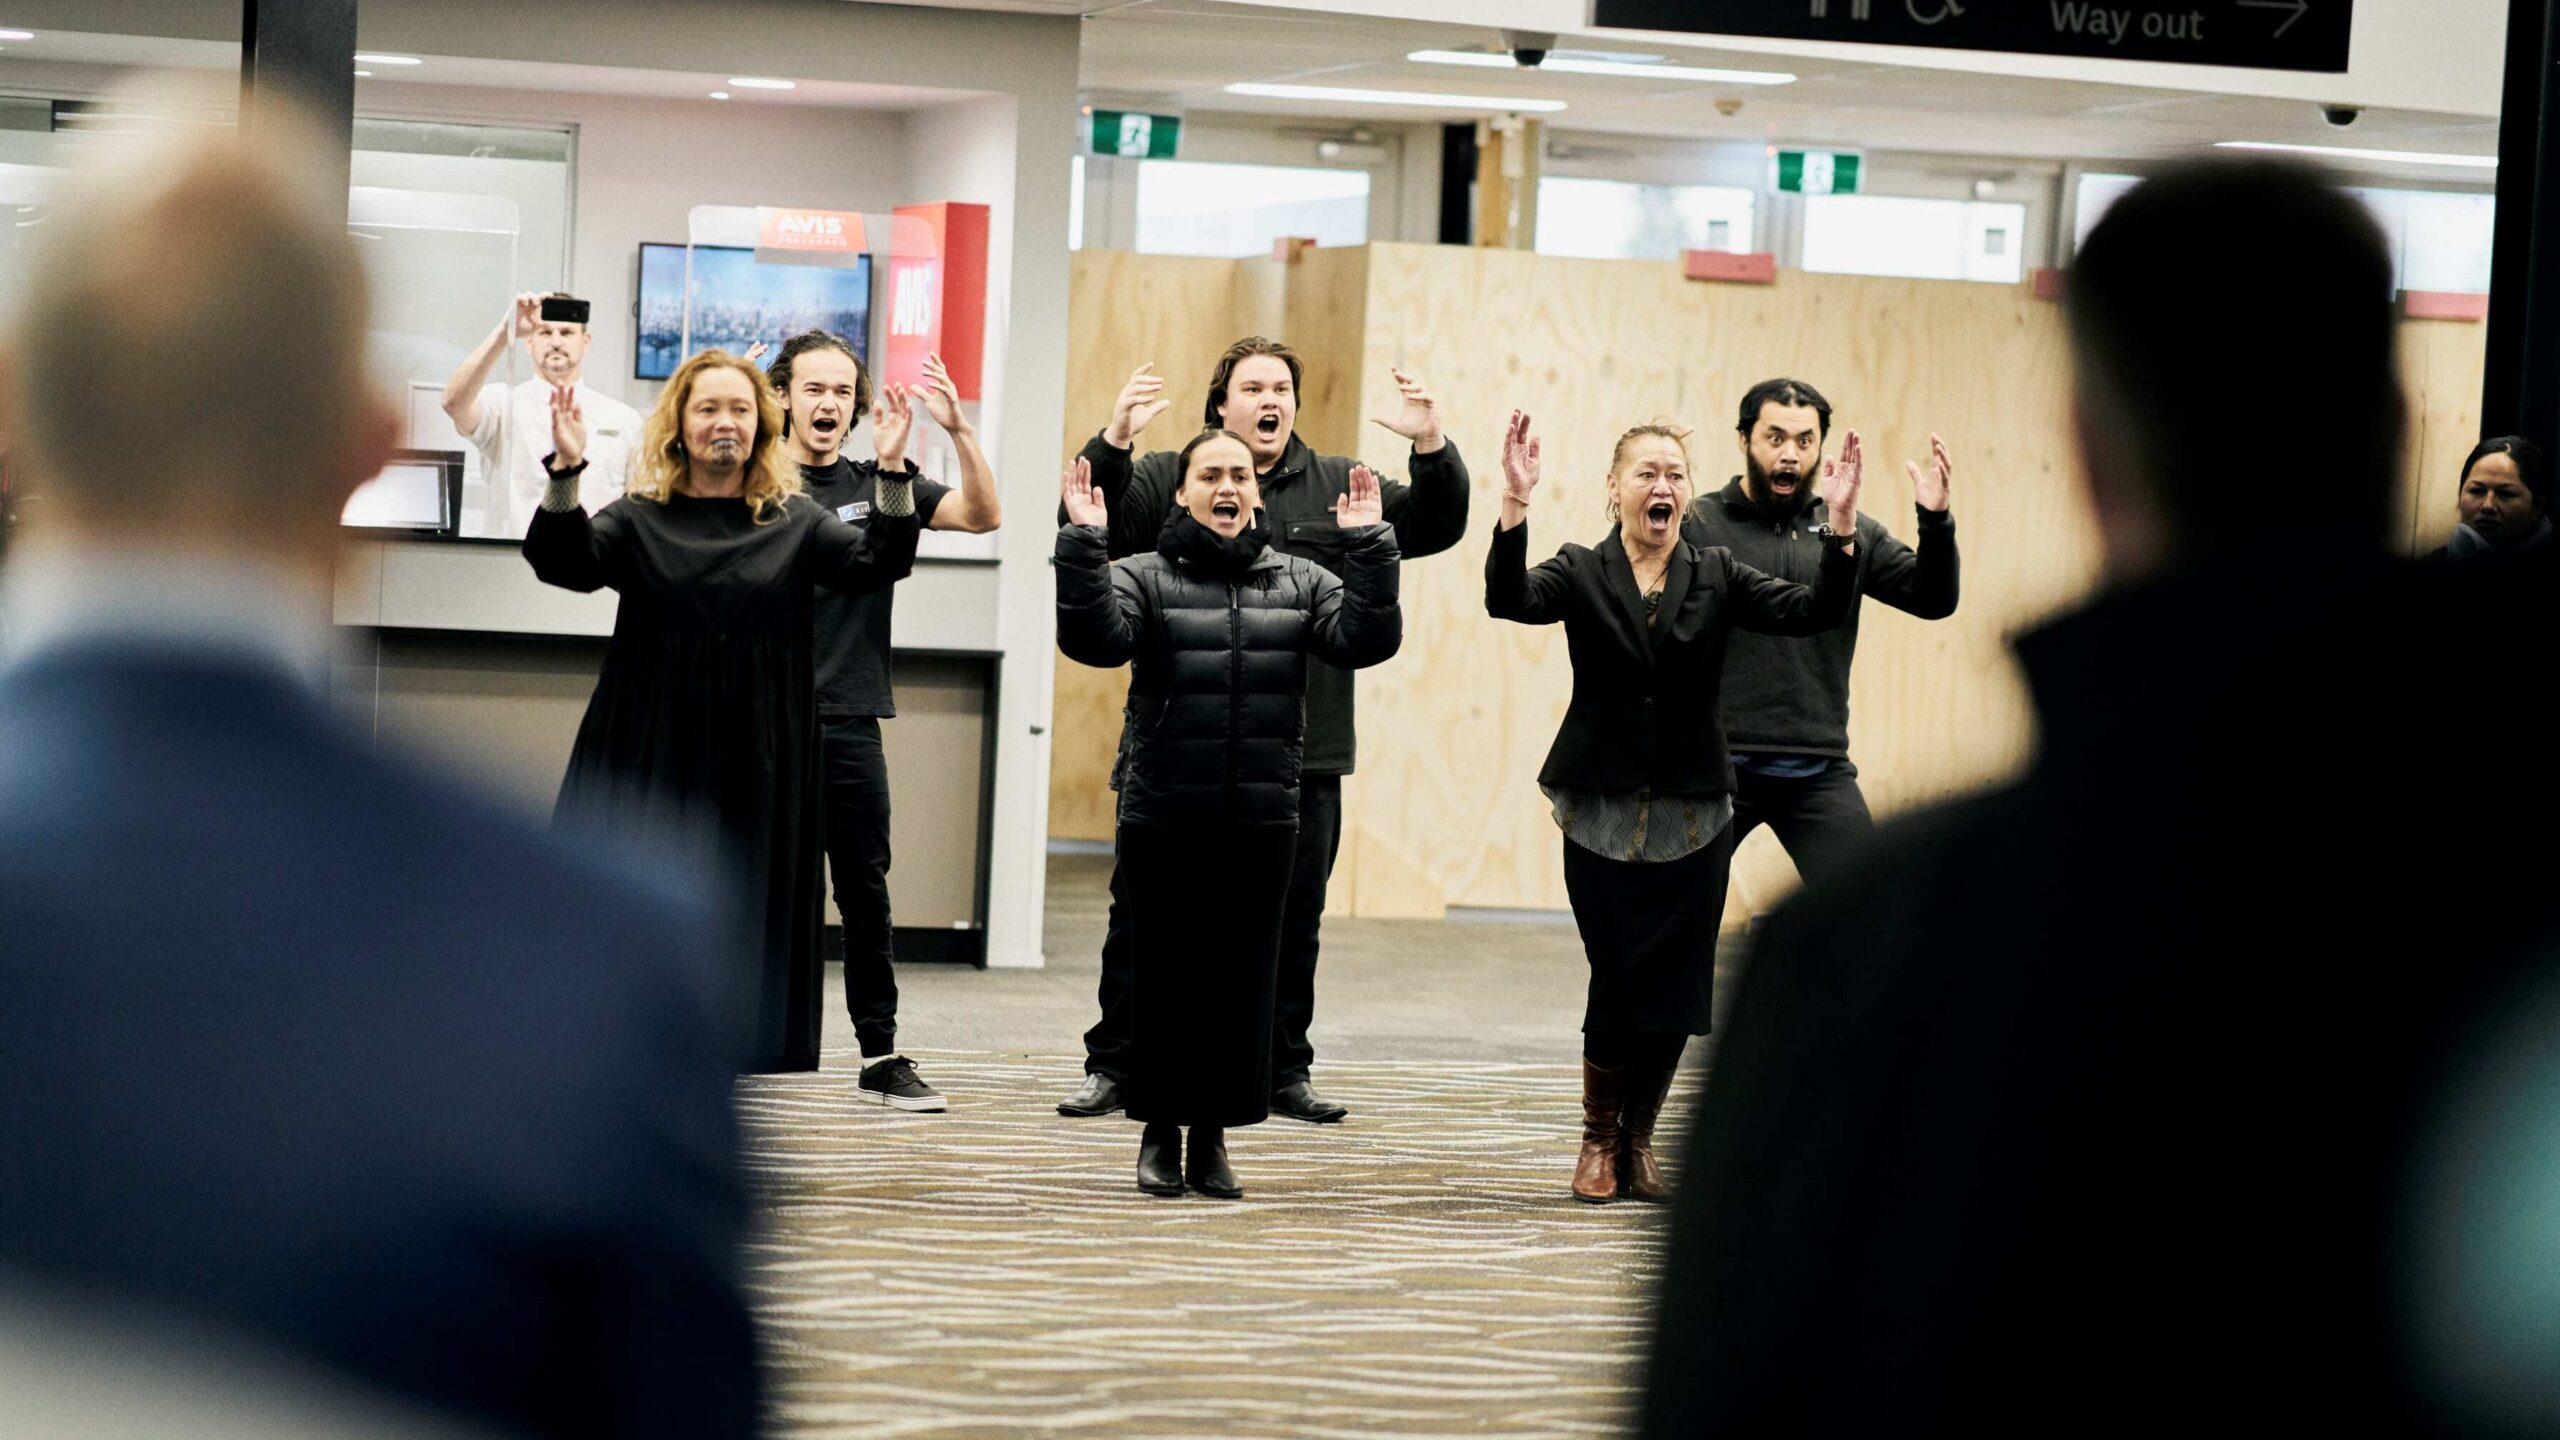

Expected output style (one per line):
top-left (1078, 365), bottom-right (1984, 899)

top-left (2481, 0), bottom-right (2560, 448)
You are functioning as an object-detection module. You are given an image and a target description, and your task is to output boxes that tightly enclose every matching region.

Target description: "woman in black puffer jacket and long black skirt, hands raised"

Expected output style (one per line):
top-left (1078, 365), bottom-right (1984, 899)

top-left (1057, 430), bottom-right (1403, 1199)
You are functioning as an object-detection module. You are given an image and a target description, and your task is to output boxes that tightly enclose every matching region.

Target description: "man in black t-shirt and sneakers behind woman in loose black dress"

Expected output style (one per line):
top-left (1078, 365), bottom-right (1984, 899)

top-left (768, 331), bottom-right (1004, 1112)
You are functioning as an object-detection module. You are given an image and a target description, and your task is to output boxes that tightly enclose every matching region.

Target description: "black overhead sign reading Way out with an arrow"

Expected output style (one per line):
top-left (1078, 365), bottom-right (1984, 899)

top-left (1592, 0), bottom-right (2355, 74)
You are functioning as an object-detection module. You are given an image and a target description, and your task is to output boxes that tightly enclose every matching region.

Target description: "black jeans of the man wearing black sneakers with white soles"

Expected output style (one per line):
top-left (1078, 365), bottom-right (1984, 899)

top-left (819, 715), bottom-right (899, 1056)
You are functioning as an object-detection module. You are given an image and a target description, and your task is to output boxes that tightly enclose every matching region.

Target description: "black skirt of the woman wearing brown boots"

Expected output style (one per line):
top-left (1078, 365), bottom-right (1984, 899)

top-left (1564, 825), bottom-right (1733, 1035)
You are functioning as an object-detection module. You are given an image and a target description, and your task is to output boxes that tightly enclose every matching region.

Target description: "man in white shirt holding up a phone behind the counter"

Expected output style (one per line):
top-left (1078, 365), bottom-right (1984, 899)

top-left (445, 292), bottom-right (640, 541)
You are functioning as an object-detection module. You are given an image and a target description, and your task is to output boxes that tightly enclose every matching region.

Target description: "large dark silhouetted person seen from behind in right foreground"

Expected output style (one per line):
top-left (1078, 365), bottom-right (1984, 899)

top-left (1641, 159), bottom-right (2560, 1437)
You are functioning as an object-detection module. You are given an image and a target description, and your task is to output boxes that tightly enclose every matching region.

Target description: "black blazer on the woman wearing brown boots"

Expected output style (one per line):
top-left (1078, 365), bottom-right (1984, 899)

top-left (1485, 520), bottom-right (1859, 794)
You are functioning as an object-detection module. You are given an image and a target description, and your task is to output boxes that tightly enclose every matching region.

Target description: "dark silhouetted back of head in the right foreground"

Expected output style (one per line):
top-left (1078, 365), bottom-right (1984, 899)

top-left (2068, 159), bottom-right (2406, 584)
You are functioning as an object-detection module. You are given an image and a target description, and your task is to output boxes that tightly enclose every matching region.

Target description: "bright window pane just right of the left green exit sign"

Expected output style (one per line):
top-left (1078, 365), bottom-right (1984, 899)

top-left (1137, 159), bottom-right (1370, 256)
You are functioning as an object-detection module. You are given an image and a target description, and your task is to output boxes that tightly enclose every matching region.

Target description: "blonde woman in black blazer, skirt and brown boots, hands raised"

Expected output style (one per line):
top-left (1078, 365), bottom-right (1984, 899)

top-left (1485, 410), bottom-right (1861, 1202)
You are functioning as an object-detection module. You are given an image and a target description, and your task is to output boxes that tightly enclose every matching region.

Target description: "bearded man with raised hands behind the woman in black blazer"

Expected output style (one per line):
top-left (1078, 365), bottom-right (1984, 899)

top-left (1682, 379), bottom-right (1956, 879)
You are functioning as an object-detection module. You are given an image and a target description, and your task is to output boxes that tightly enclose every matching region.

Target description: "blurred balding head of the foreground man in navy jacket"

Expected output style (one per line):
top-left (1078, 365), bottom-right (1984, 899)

top-left (0, 92), bottom-right (397, 569)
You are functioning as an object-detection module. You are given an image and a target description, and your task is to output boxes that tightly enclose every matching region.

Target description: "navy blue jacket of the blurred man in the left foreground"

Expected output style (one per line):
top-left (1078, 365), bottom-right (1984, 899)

top-left (0, 643), bottom-right (760, 1440)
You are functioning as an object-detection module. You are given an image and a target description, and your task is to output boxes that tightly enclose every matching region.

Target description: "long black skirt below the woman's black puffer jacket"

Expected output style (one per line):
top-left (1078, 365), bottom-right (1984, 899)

top-left (1119, 825), bottom-right (1298, 1125)
